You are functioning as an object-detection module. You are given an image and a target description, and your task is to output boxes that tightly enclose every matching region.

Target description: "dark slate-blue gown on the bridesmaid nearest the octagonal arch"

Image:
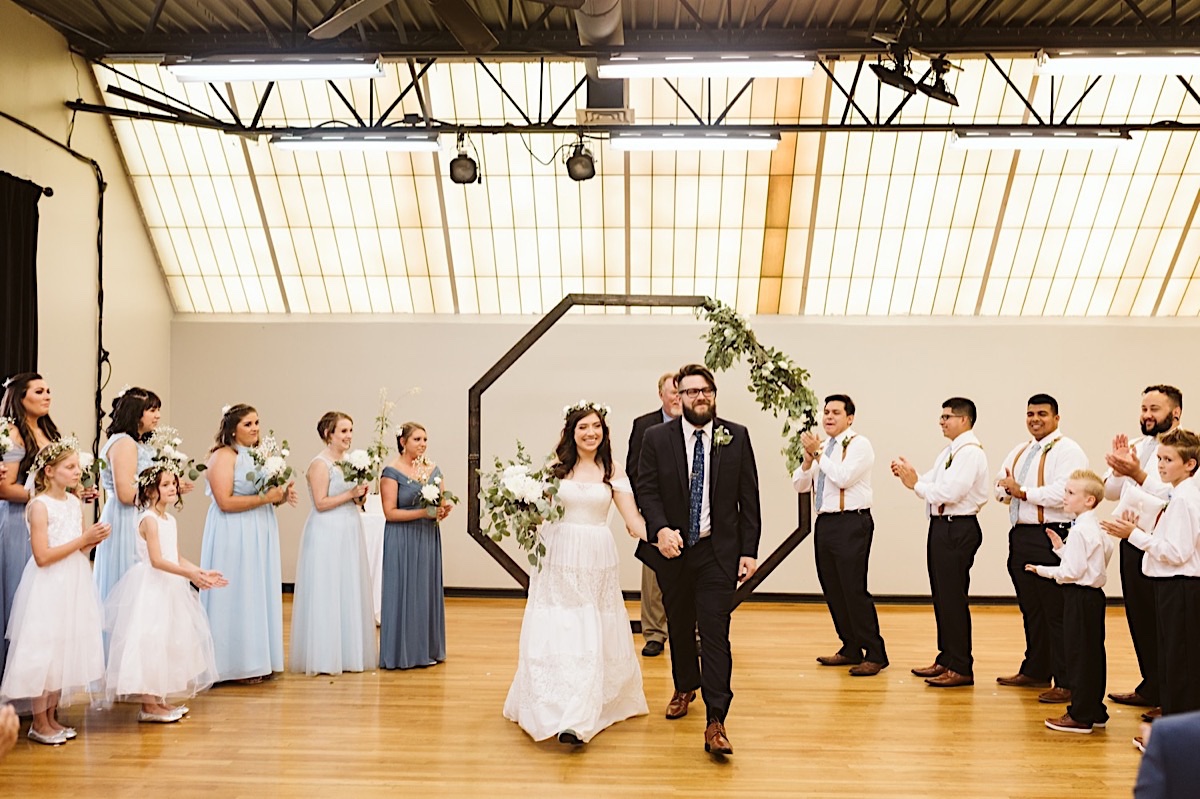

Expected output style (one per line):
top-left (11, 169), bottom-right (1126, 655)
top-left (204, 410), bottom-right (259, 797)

top-left (379, 467), bottom-right (446, 668)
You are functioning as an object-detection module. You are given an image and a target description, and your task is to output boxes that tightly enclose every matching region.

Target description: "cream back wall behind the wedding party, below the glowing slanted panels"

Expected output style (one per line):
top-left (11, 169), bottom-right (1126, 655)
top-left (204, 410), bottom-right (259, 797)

top-left (168, 313), bottom-right (1200, 595)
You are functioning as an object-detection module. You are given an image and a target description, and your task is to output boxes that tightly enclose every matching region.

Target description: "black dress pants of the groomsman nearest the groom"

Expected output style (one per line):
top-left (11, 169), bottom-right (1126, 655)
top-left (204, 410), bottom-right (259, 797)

top-left (814, 510), bottom-right (888, 666)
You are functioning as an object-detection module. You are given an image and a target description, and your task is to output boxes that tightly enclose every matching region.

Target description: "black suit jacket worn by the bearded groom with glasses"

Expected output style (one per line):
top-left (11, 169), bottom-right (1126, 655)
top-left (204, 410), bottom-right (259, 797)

top-left (637, 417), bottom-right (762, 582)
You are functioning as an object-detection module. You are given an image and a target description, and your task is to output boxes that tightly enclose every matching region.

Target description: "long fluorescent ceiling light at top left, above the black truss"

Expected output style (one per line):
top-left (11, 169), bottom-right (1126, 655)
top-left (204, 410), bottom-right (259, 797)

top-left (163, 55), bottom-right (383, 83)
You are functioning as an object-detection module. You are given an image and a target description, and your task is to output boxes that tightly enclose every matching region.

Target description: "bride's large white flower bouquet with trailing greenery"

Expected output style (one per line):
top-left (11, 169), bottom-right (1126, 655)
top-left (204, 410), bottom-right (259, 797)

top-left (479, 441), bottom-right (563, 569)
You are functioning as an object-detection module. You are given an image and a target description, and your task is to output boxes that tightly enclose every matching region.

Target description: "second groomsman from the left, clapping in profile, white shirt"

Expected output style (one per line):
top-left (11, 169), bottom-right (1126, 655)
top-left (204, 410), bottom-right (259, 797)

top-left (892, 397), bottom-right (990, 687)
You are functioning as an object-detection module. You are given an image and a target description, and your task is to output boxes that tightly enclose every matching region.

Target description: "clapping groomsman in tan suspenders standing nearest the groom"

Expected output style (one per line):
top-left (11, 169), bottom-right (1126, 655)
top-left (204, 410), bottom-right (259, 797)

top-left (792, 394), bottom-right (888, 677)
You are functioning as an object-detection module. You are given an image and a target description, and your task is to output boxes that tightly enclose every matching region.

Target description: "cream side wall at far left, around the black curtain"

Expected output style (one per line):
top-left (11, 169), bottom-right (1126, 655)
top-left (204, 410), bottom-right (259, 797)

top-left (0, 0), bottom-right (173, 441)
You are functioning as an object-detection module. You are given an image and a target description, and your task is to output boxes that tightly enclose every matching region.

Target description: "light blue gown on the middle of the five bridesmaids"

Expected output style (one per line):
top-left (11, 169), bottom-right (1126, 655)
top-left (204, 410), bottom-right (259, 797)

top-left (200, 446), bottom-right (283, 680)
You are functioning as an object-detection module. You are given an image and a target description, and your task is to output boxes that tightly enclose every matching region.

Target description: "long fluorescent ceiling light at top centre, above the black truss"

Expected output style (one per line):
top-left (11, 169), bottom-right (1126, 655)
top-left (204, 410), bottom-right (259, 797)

top-left (596, 53), bottom-right (816, 79)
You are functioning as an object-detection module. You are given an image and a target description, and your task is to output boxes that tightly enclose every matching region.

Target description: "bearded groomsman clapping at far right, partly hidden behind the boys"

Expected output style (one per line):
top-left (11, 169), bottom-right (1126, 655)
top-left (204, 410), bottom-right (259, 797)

top-left (1104, 385), bottom-right (1183, 708)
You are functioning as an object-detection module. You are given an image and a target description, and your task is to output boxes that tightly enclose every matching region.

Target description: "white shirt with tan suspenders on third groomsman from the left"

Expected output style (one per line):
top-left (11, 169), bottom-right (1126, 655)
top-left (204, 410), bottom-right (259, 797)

top-left (996, 429), bottom-right (1087, 524)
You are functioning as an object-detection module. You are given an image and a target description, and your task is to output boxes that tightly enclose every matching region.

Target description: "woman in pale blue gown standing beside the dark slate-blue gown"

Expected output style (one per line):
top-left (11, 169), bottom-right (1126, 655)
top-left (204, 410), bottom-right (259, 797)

top-left (288, 410), bottom-right (376, 674)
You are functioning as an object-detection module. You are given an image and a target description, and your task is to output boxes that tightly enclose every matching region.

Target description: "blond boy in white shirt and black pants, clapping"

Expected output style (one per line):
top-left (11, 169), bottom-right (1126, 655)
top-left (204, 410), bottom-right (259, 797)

top-left (1025, 469), bottom-right (1112, 734)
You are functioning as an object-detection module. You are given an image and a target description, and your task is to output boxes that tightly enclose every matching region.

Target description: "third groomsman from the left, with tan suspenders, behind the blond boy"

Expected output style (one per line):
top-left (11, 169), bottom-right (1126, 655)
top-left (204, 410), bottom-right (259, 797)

top-left (996, 394), bottom-right (1087, 703)
